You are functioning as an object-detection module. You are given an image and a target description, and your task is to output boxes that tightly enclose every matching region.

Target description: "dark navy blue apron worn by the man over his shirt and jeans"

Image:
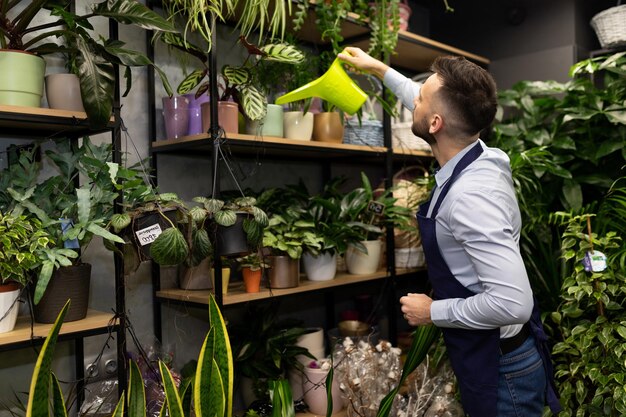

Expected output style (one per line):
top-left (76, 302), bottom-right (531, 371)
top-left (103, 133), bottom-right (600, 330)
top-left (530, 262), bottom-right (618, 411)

top-left (417, 143), bottom-right (560, 417)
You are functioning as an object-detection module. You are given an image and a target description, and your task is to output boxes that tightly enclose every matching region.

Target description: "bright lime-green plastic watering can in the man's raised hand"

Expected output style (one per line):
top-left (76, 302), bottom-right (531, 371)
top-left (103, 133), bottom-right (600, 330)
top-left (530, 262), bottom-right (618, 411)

top-left (275, 59), bottom-right (367, 114)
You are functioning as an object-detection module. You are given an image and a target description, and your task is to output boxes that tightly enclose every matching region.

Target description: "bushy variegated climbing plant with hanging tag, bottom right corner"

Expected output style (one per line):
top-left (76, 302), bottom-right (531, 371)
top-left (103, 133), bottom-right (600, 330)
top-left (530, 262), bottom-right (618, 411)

top-left (551, 213), bottom-right (626, 417)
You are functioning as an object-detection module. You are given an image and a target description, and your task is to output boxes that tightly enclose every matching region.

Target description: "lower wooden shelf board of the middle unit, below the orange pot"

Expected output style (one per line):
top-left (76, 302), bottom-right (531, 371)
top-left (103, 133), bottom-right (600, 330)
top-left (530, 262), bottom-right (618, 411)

top-left (156, 270), bottom-right (388, 305)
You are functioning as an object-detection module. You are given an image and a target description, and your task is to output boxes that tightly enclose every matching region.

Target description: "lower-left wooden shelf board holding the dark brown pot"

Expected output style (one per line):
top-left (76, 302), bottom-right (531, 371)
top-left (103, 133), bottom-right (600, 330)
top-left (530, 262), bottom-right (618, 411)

top-left (0, 310), bottom-right (117, 346)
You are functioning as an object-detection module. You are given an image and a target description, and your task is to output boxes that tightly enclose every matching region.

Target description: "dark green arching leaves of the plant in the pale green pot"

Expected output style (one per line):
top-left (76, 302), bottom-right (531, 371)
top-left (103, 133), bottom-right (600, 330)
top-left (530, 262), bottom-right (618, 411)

top-left (0, 0), bottom-right (174, 127)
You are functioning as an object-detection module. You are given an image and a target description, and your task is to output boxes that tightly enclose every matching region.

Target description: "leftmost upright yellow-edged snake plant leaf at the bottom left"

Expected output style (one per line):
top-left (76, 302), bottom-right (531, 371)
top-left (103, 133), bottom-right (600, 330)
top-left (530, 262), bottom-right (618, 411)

top-left (26, 300), bottom-right (70, 417)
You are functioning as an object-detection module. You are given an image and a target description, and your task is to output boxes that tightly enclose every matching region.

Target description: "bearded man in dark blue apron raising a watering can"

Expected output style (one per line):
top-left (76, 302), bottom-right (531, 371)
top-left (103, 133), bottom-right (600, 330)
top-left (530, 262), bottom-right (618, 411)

top-left (339, 47), bottom-right (559, 417)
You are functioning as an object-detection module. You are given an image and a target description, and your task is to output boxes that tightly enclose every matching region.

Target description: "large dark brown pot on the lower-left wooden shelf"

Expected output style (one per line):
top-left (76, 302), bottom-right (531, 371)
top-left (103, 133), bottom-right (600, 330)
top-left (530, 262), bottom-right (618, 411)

top-left (34, 264), bottom-right (91, 323)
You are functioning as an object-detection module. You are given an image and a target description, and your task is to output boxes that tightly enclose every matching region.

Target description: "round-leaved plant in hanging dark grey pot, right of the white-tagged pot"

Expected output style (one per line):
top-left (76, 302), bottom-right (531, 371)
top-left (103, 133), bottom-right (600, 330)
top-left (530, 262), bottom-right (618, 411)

top-left (194, 197), bottom-right (268, 256)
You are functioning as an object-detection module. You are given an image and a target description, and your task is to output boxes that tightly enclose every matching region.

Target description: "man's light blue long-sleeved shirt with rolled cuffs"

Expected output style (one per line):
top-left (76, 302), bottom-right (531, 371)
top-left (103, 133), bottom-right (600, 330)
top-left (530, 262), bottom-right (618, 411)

top-left (384, 69), bottom-right (533, 337)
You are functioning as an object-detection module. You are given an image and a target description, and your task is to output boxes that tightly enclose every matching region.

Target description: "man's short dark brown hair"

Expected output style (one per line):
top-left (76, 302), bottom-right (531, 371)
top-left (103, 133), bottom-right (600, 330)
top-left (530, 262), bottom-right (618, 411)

top-left (430, 56), bottom-right (497, 135)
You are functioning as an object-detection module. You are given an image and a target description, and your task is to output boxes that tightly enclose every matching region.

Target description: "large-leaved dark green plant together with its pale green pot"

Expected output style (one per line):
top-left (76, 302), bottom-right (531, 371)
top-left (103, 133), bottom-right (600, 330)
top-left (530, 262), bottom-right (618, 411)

top-left (0, 0), bottom-right (174, 126)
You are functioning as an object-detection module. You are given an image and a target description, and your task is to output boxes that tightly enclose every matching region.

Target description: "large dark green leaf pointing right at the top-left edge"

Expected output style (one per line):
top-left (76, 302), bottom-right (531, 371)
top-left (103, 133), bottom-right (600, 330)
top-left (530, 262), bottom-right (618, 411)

top-left (93, 0), bottom-right (176, 32)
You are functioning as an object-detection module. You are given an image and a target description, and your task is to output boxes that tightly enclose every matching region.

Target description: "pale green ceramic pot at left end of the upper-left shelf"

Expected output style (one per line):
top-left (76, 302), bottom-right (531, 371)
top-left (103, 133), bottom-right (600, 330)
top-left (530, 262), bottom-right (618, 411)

top-left (0, 49), bottom-right (46, 107)
